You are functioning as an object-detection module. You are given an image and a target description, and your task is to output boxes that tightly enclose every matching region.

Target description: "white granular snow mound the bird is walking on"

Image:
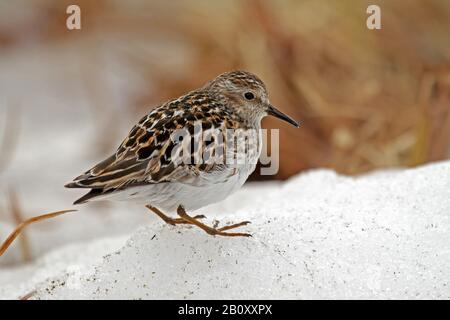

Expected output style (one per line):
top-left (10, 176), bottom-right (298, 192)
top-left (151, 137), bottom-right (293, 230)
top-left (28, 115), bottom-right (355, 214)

top-left (0, 162), bottom-right (450, 299)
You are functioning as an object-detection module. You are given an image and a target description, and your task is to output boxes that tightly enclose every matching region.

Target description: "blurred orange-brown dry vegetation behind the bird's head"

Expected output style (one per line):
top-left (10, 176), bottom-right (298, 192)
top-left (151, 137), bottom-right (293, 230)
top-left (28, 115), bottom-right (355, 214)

top-left (0, 0), bottom-right (450, 178)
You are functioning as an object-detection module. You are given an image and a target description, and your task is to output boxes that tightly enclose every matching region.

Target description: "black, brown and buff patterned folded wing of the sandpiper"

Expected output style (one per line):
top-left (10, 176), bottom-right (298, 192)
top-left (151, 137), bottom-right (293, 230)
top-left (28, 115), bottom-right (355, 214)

top-left (66, 94), bottom-right (244, 197)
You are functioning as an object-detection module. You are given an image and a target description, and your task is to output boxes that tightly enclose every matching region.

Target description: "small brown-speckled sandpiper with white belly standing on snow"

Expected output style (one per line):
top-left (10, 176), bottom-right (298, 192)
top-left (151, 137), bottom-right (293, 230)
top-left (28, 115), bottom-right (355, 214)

top-left (66, 71), bottom-right (298, 236)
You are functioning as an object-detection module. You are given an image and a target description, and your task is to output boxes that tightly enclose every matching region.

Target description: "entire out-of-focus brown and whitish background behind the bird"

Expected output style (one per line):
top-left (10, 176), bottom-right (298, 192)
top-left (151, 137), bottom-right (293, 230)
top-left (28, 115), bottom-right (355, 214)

top-left (0, 0), bottom-right (450, 261)
